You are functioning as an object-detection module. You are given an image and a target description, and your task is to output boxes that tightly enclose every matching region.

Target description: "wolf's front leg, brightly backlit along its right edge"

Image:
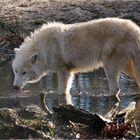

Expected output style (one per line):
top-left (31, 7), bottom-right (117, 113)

top-left (57, 68), bottom-right (73, 94)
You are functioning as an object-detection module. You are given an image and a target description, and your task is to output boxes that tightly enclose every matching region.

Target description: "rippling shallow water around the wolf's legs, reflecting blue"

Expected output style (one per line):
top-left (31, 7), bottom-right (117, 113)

top-left (0, 64), bottom-right (140, 133)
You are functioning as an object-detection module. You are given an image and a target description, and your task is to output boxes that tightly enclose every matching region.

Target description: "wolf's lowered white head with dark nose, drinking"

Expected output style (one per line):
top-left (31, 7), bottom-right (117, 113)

top-left (12, 48), bottom-right (46, 90)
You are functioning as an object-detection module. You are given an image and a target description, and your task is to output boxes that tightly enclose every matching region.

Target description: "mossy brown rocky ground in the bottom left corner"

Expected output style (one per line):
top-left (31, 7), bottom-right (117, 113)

top-left (0, 106), bottom-right (54, 139)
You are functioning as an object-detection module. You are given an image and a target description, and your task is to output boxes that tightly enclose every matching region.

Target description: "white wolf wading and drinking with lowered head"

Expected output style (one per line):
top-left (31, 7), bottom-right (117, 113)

top-left (12, 18), bottom-right (140, 94)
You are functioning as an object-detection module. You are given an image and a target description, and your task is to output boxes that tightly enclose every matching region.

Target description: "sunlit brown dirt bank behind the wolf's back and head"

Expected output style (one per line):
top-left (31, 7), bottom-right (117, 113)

top-left (0, 0), bottom-right (140, 66)
